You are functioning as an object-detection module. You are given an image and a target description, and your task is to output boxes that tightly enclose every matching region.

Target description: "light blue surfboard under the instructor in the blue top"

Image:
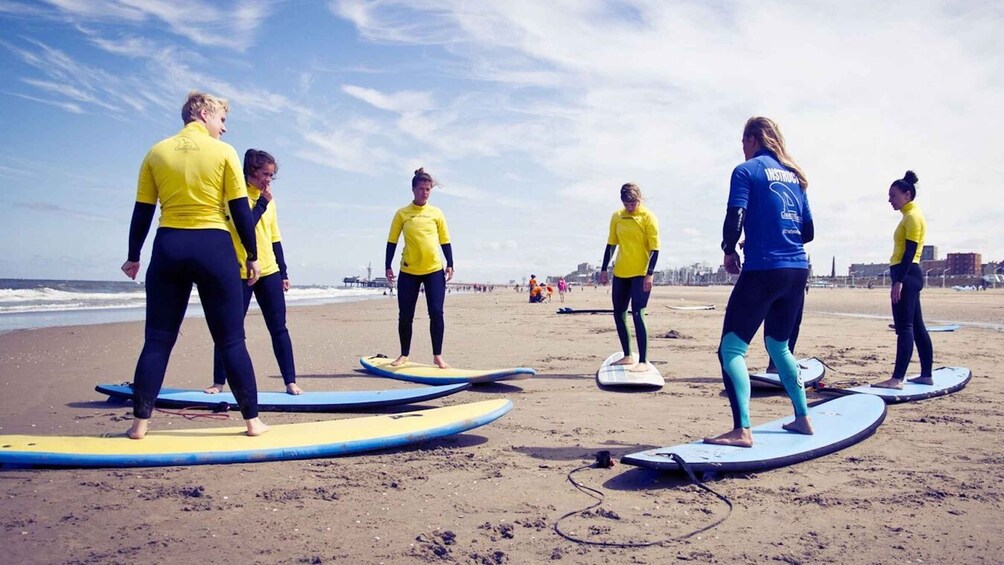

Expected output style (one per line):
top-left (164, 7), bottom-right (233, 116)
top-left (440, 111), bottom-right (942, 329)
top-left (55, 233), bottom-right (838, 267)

top-left (620, 394), bottom-right (886, 473)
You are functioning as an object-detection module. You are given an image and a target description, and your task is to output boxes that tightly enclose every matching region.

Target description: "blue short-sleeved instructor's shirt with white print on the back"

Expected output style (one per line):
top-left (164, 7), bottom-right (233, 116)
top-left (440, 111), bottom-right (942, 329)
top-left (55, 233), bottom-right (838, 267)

top-left (729, 150), bottom-right (812, 271)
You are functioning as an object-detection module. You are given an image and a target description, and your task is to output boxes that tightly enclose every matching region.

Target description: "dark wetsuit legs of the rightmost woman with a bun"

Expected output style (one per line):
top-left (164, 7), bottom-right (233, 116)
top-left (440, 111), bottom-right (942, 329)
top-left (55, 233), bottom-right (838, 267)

top-left (890, 263), bottom-right (935, 379)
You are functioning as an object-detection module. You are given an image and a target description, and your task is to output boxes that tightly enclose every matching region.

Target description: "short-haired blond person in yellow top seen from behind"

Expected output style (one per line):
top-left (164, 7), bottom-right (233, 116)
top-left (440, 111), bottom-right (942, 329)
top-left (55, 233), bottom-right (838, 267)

top-left (121, 92), bottom-right (268, 440)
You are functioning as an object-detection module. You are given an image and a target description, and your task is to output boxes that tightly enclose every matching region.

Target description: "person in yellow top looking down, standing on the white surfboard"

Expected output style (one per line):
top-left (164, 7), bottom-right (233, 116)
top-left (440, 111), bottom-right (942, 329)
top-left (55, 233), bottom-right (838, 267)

top-left (599, 183), bottom-right (659, 372)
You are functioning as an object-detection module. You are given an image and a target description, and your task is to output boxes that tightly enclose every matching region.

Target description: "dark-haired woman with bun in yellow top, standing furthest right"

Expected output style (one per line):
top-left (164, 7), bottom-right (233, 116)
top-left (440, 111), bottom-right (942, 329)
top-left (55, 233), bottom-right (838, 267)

top-left (871, 171), bottom-right (935, 389)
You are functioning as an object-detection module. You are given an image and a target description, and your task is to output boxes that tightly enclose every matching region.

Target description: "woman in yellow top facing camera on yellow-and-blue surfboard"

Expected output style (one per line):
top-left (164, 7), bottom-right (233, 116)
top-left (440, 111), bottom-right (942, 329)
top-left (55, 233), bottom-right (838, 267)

top-left (384, 169), bottom-right (453, 368)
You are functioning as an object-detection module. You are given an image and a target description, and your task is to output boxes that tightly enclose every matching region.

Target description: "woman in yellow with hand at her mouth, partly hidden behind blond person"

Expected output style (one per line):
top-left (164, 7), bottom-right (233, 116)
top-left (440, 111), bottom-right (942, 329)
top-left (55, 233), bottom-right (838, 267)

top-left (205, 150), bottom-right (303, 394)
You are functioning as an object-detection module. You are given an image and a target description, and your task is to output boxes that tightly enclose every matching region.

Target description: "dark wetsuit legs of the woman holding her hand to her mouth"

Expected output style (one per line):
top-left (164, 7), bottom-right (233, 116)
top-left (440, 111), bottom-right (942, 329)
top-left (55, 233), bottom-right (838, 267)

top-left (213, 273), bottom-right (296, 386)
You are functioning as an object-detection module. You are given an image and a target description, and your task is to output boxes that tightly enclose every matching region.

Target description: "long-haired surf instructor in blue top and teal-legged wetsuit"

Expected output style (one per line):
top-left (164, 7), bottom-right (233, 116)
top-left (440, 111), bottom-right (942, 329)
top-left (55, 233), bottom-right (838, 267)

top-left (704, 117), bottom-right (814, 448)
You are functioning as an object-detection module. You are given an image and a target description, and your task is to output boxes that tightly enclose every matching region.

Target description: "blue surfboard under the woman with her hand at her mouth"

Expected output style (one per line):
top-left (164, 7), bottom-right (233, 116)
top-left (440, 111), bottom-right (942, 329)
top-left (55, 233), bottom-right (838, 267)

top-left (94, 382), bottom-right (471, 411)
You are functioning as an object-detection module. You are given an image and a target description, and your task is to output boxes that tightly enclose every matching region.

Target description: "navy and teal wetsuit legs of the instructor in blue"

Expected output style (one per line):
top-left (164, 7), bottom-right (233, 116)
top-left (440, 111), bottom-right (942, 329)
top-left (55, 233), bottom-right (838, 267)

top-left (718, 269), bottom-right (808, 429)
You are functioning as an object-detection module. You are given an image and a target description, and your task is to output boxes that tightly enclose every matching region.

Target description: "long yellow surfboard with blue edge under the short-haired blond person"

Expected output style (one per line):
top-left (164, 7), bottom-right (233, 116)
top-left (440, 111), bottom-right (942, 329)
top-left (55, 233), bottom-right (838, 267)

top-left (0, 398), bottom-right (512, 467)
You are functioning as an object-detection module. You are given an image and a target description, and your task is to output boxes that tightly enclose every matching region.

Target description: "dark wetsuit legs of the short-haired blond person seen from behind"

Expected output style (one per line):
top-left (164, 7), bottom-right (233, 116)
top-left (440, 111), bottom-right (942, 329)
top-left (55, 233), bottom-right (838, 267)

top-left (133, 228), bottom-right (258, 419)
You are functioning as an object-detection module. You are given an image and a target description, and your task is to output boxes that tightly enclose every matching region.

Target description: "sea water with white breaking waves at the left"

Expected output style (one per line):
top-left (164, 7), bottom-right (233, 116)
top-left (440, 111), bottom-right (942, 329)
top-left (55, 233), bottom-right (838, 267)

top-left (0, 279), bottom-right (384, 332)
